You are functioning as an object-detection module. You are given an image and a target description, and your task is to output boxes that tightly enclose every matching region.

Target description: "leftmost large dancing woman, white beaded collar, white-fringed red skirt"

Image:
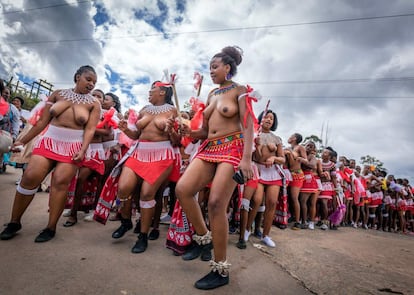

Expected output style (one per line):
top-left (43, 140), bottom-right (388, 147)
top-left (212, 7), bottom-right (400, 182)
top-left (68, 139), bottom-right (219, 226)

top-left (0, 66), bottom-right (101, 242)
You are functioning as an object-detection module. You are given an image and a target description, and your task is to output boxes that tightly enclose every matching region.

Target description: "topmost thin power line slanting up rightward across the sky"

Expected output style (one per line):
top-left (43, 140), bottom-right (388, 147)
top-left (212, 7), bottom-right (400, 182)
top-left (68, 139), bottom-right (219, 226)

top-left (9, 11), bottom-right (414, 44)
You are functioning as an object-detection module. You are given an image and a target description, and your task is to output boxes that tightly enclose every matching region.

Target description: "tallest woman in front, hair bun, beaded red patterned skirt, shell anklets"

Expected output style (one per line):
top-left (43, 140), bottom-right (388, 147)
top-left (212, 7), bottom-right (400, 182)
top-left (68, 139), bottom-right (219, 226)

top-left (176, 47), bottom-right (253, 289)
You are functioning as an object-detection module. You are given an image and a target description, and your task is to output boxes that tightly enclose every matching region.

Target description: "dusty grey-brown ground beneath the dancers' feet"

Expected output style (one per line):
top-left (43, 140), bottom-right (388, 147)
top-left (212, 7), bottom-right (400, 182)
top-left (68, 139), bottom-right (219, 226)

top-left (0, 168), bottom-right (414, 295)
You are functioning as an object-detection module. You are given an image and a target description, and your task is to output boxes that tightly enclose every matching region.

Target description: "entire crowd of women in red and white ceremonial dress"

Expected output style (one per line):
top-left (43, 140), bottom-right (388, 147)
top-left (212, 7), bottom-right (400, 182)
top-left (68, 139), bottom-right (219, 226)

top-left (0, 47), bottom-right (413, 289)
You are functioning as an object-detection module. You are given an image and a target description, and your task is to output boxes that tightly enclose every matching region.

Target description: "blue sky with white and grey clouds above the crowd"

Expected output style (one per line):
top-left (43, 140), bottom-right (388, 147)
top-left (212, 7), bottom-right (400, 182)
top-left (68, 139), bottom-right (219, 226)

top-left (0, 0), bottom-right (414, 183)
